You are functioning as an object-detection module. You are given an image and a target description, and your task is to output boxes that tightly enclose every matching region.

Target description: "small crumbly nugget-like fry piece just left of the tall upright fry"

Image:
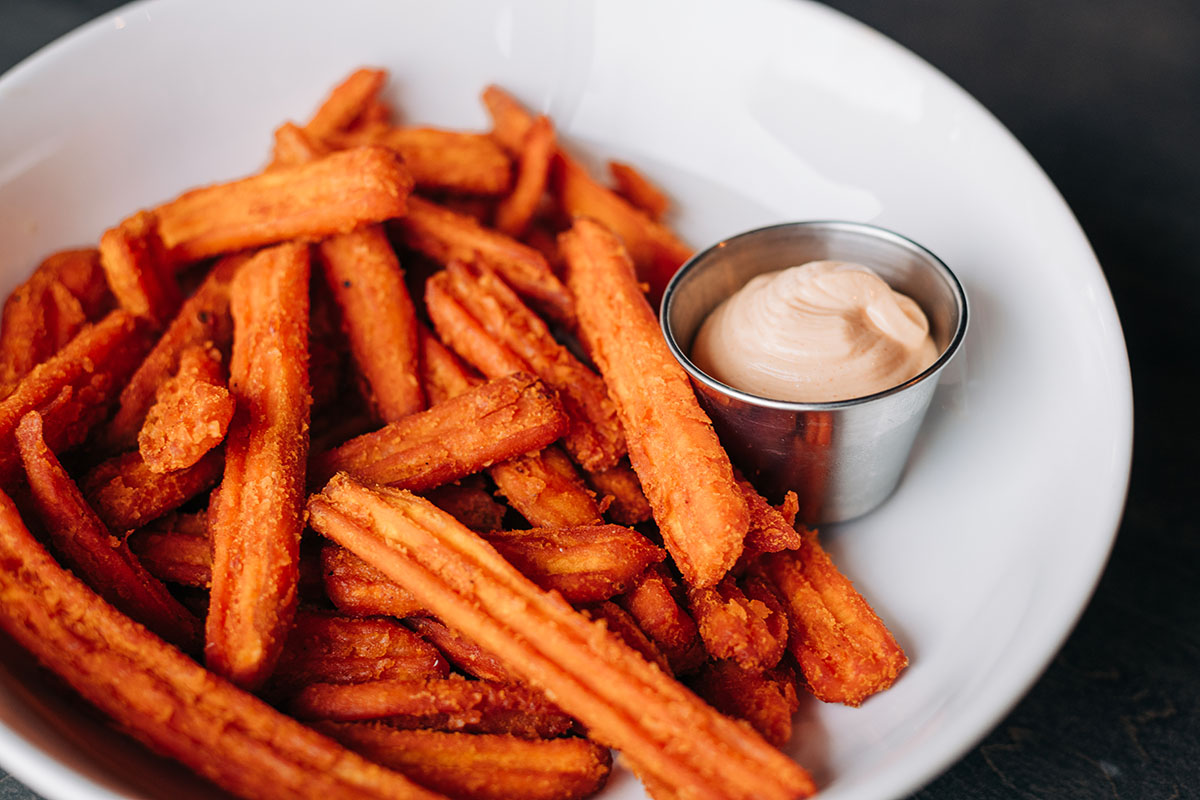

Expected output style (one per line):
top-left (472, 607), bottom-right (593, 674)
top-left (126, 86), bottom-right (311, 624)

top-left (138, 345), bottom-right (234, 473)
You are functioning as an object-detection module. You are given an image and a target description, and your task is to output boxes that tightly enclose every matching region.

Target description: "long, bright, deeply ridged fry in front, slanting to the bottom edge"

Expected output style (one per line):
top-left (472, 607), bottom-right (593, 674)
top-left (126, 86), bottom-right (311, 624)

top-left (308, 475), bottom-right (815, 800)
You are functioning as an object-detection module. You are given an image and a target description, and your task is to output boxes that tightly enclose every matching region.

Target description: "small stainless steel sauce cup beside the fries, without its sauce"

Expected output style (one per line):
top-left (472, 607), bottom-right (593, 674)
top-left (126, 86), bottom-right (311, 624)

top-left (660, 222), bottom-right (967, 524)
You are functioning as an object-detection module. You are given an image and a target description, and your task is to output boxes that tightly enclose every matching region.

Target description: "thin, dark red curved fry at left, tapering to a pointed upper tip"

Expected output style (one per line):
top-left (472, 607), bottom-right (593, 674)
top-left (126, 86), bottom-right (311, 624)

top-left (17, 411), bottom-right (202, 652)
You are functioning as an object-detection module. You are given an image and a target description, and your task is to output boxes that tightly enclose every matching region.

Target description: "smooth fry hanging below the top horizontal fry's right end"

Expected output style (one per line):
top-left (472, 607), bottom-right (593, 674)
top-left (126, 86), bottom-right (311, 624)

top-left (319, 225), bottom-right (425, 422)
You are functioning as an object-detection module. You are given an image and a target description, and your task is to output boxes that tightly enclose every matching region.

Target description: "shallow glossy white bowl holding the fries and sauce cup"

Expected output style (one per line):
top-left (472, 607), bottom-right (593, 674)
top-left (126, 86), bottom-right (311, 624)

top-left (0, 0), bottom-right (1132, 800)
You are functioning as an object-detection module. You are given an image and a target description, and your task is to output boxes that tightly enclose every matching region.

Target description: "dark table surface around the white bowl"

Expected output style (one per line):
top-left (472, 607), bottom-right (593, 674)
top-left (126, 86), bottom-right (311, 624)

top-left (0, 0), bottom-right (1200, 800)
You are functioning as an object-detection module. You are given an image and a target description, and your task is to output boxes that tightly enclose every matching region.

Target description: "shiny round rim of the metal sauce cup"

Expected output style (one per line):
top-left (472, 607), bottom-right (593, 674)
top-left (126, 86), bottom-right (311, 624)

top-left (659, 219), bottom-right (970, 411)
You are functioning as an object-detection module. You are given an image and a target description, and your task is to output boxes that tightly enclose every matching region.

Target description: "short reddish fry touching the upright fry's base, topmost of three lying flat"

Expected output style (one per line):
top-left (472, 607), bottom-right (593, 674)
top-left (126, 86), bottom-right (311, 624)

top-left (269, 610), bottom-right (450, 694)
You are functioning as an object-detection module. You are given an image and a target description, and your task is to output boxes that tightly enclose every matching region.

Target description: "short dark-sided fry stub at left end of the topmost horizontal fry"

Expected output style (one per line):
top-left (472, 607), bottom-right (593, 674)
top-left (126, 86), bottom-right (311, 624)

top-left (100, 211), bottom-right (182, 329)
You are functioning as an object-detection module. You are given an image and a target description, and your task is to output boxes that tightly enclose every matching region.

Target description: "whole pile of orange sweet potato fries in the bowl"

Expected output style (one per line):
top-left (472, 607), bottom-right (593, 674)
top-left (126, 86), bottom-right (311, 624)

top-left (0, 70), bottom-right (906, 800)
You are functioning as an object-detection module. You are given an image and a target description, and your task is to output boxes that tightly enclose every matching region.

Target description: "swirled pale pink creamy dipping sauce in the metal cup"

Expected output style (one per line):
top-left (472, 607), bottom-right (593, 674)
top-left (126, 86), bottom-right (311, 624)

top-left (691, 261), bottom-right (937, 403)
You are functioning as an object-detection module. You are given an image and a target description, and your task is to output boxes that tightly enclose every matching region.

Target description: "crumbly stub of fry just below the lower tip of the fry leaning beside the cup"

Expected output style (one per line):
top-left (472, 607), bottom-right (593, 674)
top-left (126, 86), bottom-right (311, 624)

top-left (688, 576), bottom-right (787, 672)
